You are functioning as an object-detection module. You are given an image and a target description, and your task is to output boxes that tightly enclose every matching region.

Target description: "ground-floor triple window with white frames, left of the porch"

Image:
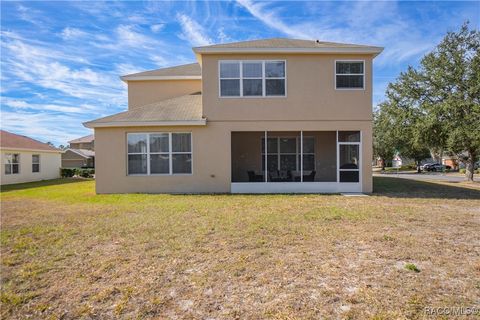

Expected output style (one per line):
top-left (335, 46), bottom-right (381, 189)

top-left (127, 132), bottom-right (192, 175)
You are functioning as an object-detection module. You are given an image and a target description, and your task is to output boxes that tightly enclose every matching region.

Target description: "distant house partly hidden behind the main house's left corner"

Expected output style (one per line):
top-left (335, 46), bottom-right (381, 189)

top-left (62, 134), bottom-right (95, 168)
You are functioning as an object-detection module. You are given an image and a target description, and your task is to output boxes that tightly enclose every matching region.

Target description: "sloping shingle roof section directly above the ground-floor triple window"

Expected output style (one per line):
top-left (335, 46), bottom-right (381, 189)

top-left (84, 93), bottom-right (205, 128)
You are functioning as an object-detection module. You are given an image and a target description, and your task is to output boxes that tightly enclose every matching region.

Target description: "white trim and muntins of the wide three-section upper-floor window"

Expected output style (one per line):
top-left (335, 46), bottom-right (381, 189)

top-left (218, 59), bottom-right (287, 99)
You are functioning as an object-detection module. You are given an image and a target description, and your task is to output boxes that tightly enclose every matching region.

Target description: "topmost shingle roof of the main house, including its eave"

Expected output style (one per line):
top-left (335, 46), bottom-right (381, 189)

top-left (193, 38), bottom-right (383, 54)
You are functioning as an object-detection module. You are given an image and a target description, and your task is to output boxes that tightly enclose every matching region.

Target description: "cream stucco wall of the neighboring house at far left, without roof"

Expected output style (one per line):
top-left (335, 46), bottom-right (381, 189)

top-left (0, 149), bottom-right (61, 185)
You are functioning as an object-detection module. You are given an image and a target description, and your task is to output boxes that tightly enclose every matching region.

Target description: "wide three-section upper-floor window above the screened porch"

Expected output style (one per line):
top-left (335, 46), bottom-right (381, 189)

top-left (220, 60), bottom-right (286, 97)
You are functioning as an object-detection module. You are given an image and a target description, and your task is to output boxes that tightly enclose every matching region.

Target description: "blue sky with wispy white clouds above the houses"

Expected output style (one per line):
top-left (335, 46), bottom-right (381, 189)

top-left (1, 0), bottom-right (480, 145)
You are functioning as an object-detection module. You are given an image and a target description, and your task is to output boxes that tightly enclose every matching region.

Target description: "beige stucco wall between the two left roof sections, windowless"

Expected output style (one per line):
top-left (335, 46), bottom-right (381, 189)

top-left (128, 80), bottom-right (202, 109)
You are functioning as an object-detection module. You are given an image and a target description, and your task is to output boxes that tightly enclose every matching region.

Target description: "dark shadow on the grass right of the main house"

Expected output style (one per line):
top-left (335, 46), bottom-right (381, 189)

top-left (373, 177), bottom-right (480, 199)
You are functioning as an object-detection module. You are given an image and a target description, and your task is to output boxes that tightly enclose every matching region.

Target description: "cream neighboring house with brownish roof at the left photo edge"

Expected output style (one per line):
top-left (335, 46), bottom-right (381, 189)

top-left (0, 130), bottom-right (62, 185)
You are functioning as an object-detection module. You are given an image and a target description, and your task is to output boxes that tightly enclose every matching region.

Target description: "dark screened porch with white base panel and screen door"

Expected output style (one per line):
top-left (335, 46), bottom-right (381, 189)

top-left (231, 131), bottom-right (361, 193)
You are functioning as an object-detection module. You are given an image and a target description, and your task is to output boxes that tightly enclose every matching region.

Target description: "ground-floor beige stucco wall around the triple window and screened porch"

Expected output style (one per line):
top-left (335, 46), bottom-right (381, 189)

top-left (95, 121), bottom-right (372, 193)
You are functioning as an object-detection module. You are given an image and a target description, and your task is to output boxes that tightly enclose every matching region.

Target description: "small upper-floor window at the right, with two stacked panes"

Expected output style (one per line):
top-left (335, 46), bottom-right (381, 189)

top-left (335, 61), bottom-right (365, 89)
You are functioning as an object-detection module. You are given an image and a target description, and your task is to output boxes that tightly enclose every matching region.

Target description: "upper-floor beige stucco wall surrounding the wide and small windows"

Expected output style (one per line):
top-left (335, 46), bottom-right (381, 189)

top-left (202, 54), bottom-right (372, 121)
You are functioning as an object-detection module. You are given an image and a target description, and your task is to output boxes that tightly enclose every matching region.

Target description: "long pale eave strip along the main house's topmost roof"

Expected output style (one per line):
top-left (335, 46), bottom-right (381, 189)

top-left (193, 47), bottom-right (383, 56)
